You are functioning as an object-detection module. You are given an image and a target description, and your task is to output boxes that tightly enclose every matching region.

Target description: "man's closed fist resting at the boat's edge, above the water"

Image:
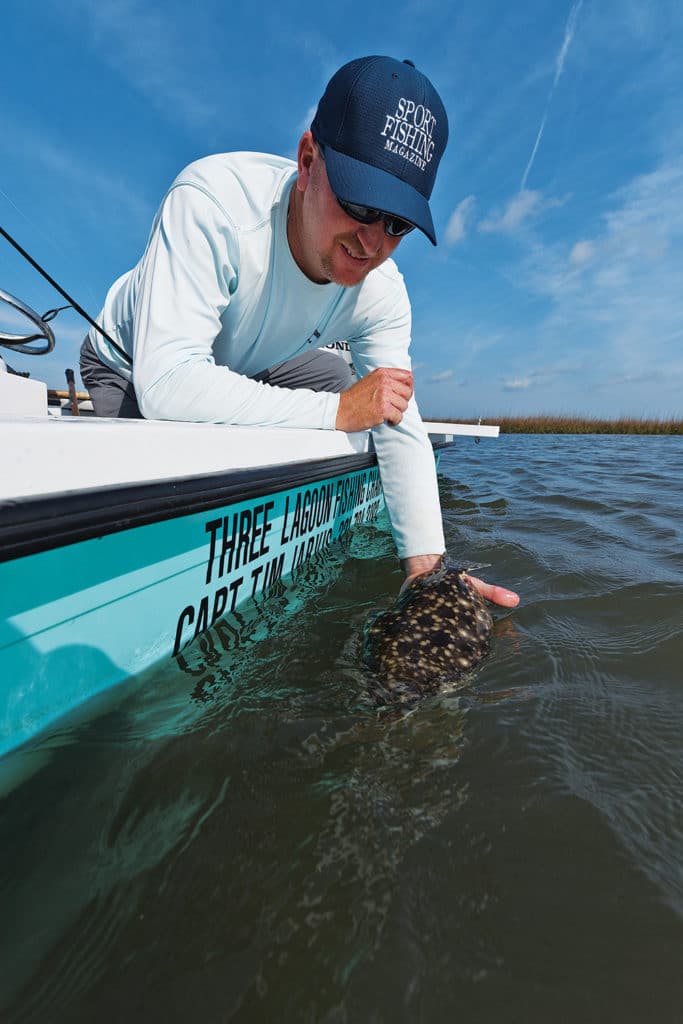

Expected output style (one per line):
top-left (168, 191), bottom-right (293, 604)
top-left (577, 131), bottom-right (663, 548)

top-left (335, 367), bottom-right (413, 432)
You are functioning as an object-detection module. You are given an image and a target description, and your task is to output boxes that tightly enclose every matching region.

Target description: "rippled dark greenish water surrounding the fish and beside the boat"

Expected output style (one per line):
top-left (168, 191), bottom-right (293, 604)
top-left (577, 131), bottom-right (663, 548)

top-left (0, 436), bottom-right (683, 1024)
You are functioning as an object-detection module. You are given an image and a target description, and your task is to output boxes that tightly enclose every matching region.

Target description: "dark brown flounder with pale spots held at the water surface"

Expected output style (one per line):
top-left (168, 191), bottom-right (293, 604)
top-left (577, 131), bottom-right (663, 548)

top-left (362, 560), bottom-right (494, 703)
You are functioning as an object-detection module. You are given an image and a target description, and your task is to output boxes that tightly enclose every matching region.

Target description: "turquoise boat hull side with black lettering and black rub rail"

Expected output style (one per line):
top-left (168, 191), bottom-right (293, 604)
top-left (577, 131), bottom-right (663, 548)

top-left (0, 453), bottom-right (384, 755)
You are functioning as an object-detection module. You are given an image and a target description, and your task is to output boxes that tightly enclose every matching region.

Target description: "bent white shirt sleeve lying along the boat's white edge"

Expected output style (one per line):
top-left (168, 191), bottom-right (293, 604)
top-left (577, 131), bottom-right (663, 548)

top-left (133, 184), bottom-right (339, 429)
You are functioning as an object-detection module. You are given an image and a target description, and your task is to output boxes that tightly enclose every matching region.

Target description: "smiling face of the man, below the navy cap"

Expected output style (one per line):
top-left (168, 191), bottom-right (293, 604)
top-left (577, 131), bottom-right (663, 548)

top-left (289, 132), bottom-right (400, 288)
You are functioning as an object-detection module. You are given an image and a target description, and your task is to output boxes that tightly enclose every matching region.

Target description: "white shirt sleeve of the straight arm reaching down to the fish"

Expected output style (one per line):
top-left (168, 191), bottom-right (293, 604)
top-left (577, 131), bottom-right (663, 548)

top-left (350, 278), bottom-right (445, 558)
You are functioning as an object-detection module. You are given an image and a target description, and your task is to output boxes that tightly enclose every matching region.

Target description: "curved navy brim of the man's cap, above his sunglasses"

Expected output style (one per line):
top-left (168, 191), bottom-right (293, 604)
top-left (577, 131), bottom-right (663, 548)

top-left (325, 145), bottom-right (436, 246)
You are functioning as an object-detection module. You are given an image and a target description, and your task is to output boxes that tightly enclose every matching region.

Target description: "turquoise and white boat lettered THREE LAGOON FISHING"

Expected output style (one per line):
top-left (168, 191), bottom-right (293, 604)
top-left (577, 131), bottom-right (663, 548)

top-left (0, 288), bottom-right (498, 757)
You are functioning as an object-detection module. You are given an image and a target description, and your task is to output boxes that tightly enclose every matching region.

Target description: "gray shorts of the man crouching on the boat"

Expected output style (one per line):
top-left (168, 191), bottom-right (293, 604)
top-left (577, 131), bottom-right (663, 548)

top-left (81, 335), bottom-right (353, 420)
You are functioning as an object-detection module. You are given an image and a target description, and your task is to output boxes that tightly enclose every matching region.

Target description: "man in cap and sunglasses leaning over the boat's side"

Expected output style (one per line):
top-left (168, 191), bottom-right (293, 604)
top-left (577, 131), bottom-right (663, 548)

top-left (81, 56), bottom-right (517, 604)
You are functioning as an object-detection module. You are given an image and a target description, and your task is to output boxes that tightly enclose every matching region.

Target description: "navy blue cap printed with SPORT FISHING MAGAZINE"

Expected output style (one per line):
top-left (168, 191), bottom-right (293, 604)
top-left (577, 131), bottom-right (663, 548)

top-left (310, 56), bottom-right (449, 245)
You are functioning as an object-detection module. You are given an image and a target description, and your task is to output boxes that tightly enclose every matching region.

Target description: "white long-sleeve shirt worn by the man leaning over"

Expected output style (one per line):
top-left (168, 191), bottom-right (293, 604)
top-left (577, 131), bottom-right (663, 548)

top-left (90, 153), bottom-right (444, 557)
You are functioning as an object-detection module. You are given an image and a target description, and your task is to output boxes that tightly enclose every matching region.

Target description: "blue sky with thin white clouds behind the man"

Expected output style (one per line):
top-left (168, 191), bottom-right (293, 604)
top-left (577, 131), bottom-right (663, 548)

top-left (0, 0), bottom-right (683, 422)
